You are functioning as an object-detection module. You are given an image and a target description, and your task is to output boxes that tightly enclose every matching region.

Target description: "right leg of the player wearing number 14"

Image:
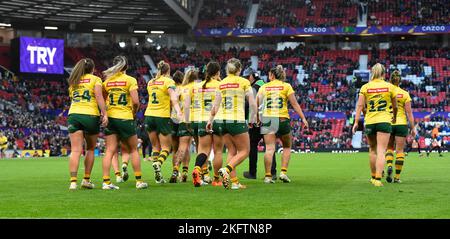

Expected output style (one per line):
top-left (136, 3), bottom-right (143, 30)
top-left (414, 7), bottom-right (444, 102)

top-left (122, 134), bottom-right (148, 189)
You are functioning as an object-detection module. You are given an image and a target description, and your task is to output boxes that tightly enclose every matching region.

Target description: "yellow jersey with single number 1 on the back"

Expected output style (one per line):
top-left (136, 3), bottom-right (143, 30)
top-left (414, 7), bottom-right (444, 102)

top-left (145, 76), bottom-right (176, 118)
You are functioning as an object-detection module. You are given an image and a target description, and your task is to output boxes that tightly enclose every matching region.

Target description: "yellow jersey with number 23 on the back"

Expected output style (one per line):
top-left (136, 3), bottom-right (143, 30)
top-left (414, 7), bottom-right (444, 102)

top-left (258, 80), bottom-right (294, 119)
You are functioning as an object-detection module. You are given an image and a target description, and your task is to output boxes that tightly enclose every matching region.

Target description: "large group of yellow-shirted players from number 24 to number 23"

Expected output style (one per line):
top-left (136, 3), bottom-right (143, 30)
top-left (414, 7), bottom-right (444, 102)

top-left (68, 56), bottom-right (308, 190)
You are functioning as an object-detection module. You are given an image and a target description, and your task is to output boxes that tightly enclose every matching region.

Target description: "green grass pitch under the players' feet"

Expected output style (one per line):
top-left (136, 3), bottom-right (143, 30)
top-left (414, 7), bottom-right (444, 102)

top-left (0, 153), bottom-right (450, 218)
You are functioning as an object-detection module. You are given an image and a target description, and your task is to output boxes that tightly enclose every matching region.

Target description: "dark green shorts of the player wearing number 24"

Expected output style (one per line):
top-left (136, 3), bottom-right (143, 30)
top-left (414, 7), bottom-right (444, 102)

top-left (67, 114), bottom-right (100, 134)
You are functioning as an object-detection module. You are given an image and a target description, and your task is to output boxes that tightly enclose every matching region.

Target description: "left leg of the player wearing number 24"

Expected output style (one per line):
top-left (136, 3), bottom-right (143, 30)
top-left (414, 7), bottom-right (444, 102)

top-left (69, 130), bottom-right (84, 190)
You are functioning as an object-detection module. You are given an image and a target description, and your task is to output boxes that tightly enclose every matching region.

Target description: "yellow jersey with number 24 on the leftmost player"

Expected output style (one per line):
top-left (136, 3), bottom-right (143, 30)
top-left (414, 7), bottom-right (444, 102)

top-left (69, 74), bottom-right (102, 115)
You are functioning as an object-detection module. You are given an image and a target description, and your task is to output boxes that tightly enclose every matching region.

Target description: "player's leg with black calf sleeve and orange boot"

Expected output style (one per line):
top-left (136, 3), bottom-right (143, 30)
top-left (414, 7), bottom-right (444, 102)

top-left (192, 134), bottom-right (212, 187)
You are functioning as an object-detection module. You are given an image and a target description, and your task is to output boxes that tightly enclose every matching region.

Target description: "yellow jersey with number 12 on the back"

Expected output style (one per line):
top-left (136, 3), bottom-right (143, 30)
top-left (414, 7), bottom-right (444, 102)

top-left (359, 79), bottom-right (396, 125)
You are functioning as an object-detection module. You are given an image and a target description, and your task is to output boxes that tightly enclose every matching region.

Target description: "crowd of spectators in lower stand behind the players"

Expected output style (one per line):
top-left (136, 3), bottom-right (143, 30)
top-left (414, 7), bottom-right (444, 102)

top-left (0, 42), bottom-right (450, 154)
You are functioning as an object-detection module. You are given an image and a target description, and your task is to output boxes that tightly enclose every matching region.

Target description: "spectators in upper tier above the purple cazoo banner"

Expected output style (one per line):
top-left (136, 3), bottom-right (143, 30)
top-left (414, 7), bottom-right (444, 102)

top-left (197, 0), bottom-right (450, 28)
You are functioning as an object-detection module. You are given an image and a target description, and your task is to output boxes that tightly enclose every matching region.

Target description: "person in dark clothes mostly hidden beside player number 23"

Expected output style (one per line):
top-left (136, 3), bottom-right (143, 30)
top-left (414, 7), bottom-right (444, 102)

top-left (243, 68), bottom-right (277, 180)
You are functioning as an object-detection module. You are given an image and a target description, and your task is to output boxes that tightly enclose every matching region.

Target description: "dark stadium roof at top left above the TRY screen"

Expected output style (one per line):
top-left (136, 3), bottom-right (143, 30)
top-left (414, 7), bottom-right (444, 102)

top-left (0, 0), bottom-right (190, 33)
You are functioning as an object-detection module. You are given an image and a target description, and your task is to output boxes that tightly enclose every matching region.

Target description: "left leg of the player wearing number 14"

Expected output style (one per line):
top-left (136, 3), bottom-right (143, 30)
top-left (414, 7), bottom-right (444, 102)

top-left (102, 134), bottom-right (119, 190)
